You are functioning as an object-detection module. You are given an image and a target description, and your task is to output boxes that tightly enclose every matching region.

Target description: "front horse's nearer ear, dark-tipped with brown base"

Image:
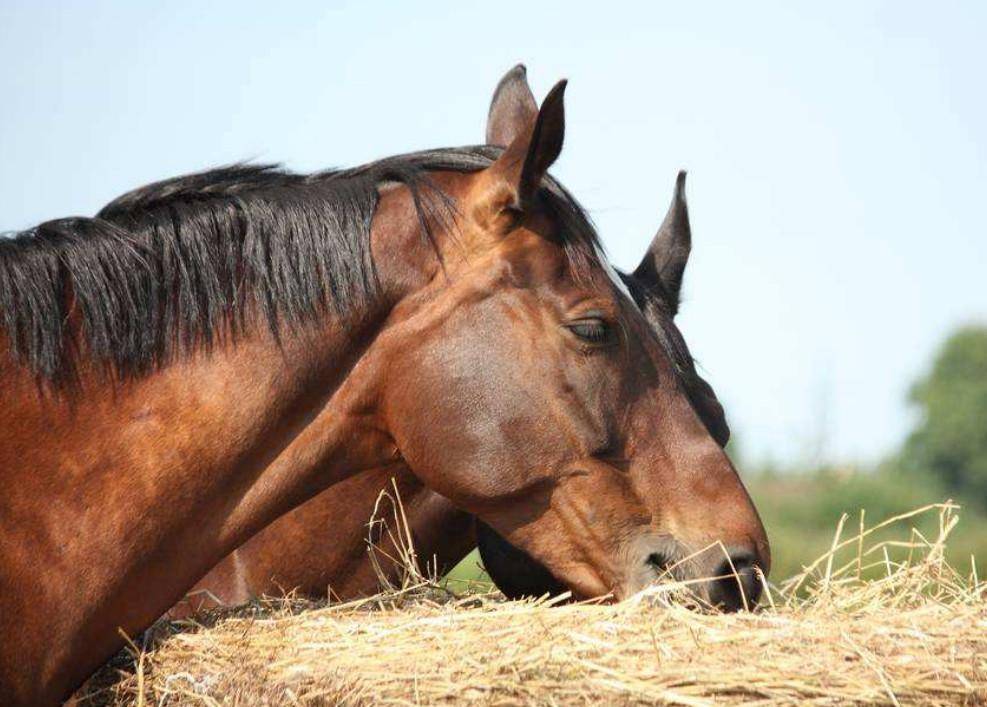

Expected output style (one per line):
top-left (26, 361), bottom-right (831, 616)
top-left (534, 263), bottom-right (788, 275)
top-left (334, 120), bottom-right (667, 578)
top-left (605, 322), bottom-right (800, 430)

top-left (483, 80), bottom-right (566, 218)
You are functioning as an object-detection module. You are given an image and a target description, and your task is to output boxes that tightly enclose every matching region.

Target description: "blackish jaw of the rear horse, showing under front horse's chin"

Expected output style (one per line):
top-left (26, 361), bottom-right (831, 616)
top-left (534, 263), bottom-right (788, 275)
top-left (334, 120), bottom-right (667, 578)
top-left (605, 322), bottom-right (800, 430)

top-left (476, 519), bottom-right (568, 599)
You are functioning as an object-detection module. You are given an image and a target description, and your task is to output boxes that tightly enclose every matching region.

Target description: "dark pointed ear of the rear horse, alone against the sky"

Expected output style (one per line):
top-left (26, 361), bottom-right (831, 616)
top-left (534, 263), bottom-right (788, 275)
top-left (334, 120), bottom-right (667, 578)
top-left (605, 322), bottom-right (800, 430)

top-left (634, 170), bottom-right (692, 313)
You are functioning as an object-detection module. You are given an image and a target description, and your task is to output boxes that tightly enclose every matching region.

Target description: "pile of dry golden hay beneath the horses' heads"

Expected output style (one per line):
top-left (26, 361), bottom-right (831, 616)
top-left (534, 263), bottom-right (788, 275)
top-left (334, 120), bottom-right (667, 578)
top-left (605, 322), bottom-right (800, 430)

top-left (83, 504), bottom-right (987, 705)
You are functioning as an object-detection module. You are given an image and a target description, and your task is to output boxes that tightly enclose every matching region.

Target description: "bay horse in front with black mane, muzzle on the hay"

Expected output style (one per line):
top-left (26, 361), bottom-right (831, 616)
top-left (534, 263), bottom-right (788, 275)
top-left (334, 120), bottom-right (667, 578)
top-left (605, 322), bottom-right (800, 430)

top-left (0, 65), bottom-right (769, 704)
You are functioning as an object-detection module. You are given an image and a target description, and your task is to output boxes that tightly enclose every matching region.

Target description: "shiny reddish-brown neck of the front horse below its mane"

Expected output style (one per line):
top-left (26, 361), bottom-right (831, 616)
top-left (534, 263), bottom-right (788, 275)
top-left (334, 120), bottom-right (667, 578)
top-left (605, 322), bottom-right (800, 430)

top-left (0, 181), bottom-right (444, 701)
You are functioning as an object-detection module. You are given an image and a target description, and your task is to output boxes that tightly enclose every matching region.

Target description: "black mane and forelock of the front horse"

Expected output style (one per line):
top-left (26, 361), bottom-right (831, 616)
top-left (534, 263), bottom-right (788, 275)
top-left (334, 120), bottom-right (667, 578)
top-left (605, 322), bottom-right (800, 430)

top-left (0, 147), bottom-right (598, 383)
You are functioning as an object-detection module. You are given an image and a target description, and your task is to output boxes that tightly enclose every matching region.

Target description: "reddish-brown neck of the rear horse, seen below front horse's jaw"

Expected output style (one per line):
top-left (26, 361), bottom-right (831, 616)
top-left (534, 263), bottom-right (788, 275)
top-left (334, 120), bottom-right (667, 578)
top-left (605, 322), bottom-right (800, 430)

top-left (186, 463), bottom-right (476, 617)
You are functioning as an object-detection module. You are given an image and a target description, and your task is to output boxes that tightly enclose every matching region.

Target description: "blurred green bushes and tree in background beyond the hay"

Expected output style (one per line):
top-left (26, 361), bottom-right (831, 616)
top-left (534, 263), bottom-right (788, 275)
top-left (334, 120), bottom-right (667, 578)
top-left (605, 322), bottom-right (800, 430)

top-left (760, 325), bottom-right (987, 579)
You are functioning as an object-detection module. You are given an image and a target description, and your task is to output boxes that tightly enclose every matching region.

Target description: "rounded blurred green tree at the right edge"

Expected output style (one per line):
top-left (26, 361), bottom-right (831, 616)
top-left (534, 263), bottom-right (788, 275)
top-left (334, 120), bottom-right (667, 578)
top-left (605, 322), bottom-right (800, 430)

top-left (900, 325), bottom-right (987, 508)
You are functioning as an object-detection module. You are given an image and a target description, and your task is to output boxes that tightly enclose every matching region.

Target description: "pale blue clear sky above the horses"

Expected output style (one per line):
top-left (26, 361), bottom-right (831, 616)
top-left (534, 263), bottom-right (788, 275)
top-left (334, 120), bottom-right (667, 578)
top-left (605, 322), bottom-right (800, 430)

top-left (0, 0), bottom-right (987, 464)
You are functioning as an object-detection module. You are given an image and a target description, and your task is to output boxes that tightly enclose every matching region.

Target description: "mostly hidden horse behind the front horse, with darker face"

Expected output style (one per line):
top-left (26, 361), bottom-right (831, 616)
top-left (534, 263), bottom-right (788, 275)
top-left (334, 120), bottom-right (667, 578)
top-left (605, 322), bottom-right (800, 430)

top-left (176, 67), bottom-right (740, 617)
